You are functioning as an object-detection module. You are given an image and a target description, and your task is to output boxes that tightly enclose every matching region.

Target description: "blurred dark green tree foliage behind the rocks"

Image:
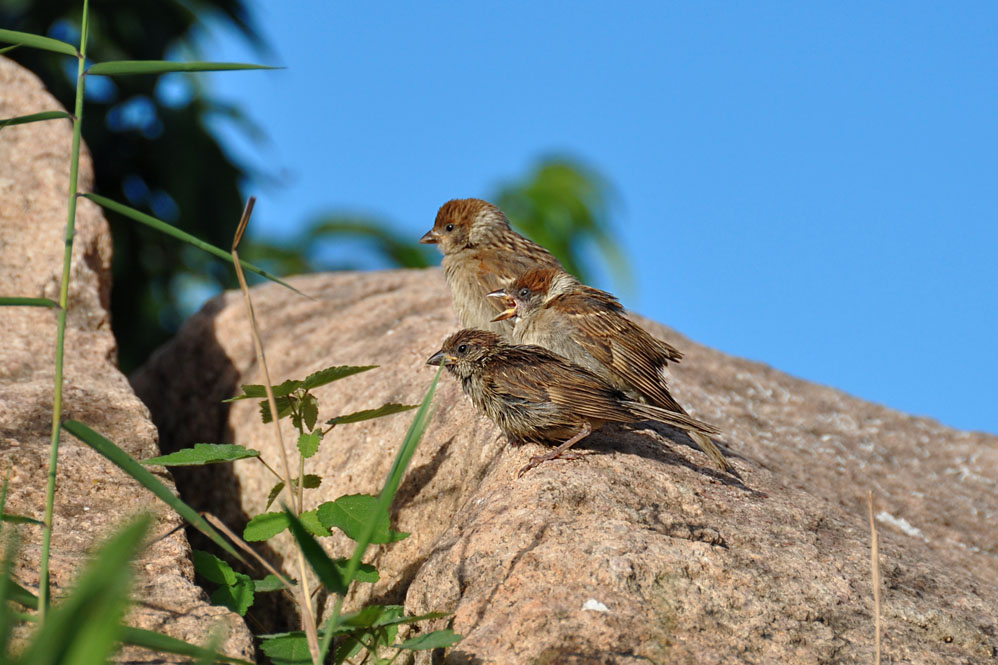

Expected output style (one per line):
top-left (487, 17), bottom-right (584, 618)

top-left (0, 0), bottom-right (627, 373)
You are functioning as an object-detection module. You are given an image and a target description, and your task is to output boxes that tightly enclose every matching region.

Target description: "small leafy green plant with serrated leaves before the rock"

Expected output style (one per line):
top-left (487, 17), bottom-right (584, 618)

top-left (143, 365), bottom-right (459, 663)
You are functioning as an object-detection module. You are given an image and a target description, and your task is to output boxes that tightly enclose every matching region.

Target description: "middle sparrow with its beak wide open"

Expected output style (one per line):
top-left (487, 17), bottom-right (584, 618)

top-left (489, 268), bottom-right (730, 471)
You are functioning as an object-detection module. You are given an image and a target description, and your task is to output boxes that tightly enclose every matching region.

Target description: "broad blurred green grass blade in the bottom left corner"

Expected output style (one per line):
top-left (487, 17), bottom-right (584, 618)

top-left (22, 516), bottom-right (151, 665)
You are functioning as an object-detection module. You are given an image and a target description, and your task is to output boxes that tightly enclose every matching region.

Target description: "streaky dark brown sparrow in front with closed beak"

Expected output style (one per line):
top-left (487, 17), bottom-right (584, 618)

top-left (426, 329), bottom-right (716, 475)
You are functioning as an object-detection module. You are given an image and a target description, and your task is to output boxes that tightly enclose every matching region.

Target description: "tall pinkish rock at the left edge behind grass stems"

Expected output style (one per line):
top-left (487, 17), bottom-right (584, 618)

top-left (0, 57), bottom-right (253, 662)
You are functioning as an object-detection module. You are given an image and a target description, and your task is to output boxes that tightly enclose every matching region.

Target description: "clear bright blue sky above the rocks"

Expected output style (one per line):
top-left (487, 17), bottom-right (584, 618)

top-left (186, 1), bottom-right (998, 432)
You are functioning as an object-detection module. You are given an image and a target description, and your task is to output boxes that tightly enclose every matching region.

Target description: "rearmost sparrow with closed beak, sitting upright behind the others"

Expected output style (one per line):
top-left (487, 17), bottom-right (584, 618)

top-left (419, 199), bottom-right (561, 336)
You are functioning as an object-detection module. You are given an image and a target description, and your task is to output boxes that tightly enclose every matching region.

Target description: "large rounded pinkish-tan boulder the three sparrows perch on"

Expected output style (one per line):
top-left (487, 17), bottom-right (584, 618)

top-left (133, 270), bottom-right (998, 664)
